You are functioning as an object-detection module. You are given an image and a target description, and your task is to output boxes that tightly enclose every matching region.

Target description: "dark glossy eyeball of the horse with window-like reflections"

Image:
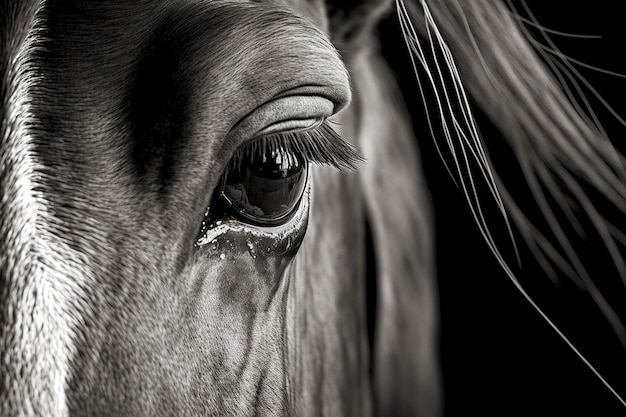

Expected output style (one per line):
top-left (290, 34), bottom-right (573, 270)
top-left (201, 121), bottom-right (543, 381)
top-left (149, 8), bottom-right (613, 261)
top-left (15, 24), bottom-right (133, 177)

top-left (214, 148), bottom-right (307, 225)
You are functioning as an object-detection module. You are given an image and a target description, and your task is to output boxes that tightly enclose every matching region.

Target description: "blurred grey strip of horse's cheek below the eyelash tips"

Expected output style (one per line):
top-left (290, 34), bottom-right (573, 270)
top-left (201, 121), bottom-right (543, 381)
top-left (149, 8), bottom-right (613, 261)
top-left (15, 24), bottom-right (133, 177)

top-left (287, 167), bottom-right (371, 415)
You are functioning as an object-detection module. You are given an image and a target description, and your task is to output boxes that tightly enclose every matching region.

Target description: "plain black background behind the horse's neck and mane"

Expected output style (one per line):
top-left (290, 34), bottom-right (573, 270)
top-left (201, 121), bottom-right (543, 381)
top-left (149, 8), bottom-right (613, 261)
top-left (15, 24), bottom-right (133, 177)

top-left (380, 0), bottom-right (626, 417)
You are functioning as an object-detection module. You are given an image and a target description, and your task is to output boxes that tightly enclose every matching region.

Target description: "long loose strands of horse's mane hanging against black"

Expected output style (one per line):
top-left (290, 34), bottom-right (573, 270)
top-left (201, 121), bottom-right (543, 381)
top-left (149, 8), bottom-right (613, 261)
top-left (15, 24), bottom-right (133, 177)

top-left (396, 0), bottom-right (626, 406)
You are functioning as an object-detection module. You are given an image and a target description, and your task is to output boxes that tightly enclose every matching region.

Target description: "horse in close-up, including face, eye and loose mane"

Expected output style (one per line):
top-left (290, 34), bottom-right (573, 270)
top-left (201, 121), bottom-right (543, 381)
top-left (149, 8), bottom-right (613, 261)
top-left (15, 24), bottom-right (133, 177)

top-left (0, 0), bottom-right (626, 416)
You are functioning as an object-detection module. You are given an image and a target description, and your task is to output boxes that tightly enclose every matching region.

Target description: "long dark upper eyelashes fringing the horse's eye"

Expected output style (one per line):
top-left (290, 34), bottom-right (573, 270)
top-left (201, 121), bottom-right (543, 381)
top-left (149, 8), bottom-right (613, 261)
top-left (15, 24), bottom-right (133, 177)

top-left (226, 122), bottom-right (365, 172)
